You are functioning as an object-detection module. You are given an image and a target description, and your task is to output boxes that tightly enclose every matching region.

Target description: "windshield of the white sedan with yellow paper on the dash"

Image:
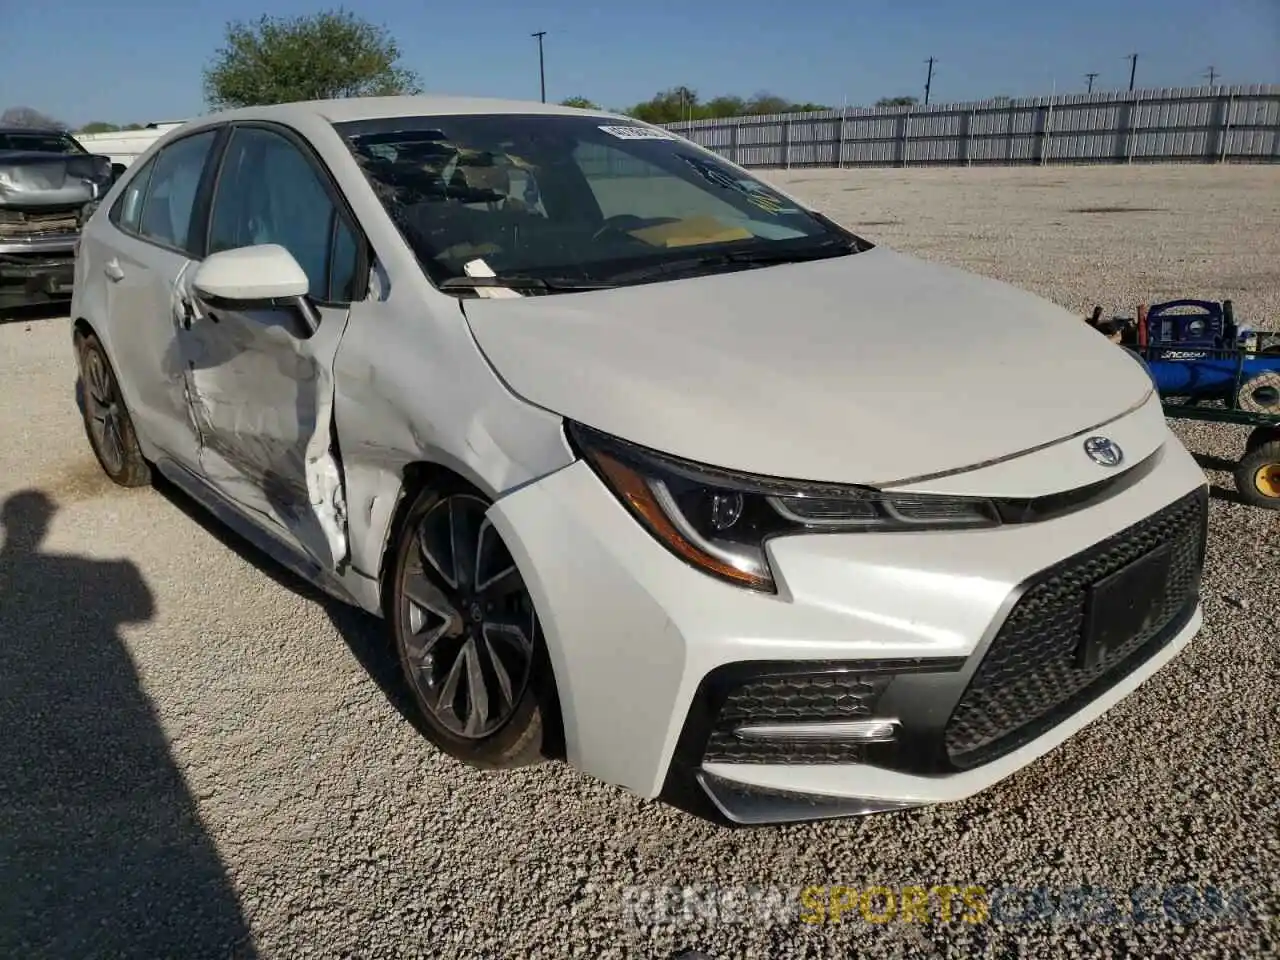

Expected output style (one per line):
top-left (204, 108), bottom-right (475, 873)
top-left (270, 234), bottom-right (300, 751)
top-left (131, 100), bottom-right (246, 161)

top-left (335, 114), bottom-right (870, 288)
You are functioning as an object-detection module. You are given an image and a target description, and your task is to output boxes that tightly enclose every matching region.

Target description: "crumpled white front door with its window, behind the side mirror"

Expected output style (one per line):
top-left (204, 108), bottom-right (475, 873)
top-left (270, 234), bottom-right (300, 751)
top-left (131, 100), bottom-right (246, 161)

top-left (179, 123), bottom-right (367, 570)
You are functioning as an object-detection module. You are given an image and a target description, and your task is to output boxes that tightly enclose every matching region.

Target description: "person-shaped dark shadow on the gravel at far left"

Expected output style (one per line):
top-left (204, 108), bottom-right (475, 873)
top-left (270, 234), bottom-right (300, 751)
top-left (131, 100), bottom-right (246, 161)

top-left (0, 490), bottom-right (256, 960)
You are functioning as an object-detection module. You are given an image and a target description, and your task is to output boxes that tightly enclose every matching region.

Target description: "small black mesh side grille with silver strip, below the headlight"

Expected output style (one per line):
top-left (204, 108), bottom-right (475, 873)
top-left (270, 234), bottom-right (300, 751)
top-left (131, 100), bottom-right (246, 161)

top-left (703, 671), bottom-right (890, 763)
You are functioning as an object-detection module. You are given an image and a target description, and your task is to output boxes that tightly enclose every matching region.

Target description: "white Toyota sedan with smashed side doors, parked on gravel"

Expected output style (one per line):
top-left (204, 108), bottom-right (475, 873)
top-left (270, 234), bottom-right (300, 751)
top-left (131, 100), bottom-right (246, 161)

top-left (72, 97), bottom-right (1207, 823)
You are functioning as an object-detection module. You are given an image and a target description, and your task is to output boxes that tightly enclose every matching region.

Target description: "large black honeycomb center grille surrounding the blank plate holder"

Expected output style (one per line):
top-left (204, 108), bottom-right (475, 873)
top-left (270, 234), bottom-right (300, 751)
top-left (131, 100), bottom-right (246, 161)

top-left (945, 488), bottom-right (1208, 767)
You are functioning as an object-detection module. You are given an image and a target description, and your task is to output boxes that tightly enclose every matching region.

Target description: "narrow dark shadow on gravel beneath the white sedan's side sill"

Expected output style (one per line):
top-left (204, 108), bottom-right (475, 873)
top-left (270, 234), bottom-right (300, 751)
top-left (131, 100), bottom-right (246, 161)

top-left (152, 474), bottom-right (425, 733)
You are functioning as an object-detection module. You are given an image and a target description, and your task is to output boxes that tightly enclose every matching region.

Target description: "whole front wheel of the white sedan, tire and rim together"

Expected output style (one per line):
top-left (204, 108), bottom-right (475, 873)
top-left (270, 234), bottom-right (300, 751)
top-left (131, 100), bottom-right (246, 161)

top-left (385, 483), bottom-right (558, 769)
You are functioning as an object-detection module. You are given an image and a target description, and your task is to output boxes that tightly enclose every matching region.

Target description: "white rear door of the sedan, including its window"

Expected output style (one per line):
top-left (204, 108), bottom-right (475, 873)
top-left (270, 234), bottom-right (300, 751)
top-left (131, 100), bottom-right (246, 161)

top-left (93, 128), bottom-right (219, 470)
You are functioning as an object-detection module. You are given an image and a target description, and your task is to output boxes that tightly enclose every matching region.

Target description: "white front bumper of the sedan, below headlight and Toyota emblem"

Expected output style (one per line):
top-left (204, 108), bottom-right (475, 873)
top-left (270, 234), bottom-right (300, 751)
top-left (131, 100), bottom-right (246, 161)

top-left (490, 409), bottom-right (1207, 823)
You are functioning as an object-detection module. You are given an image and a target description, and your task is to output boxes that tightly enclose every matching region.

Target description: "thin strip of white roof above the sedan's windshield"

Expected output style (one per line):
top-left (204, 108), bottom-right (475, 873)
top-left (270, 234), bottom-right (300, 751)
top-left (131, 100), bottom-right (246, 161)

top-left (190, 95), bottom-right (629, 123)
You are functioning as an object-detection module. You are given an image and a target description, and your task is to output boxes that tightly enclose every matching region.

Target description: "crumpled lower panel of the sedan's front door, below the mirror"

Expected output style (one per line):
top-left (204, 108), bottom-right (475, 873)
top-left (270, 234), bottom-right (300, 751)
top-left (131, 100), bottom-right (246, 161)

top-left (179, 284), bottom-right (348, 570)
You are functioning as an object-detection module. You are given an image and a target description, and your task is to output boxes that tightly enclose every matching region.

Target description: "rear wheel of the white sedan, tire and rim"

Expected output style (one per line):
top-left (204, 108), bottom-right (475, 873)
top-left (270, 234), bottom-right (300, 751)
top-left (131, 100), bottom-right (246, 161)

top-left (76, 333), bottom-right (151, 486)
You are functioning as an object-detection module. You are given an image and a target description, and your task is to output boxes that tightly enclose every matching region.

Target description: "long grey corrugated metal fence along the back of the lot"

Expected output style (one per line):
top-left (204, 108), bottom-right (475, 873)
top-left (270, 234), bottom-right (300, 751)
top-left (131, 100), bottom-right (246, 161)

top-left (667, 84), bottom-right (1280, 168)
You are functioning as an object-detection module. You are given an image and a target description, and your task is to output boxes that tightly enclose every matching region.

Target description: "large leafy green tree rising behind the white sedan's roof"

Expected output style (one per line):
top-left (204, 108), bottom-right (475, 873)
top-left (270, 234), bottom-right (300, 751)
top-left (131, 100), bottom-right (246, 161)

top-left (204, 8), bottom-right (420, 110)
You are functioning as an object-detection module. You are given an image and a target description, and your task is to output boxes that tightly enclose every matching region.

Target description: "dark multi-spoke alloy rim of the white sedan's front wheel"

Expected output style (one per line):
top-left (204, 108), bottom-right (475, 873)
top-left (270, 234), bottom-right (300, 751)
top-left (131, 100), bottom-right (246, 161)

top-left (399, 493), bottom-right (539, 740)
